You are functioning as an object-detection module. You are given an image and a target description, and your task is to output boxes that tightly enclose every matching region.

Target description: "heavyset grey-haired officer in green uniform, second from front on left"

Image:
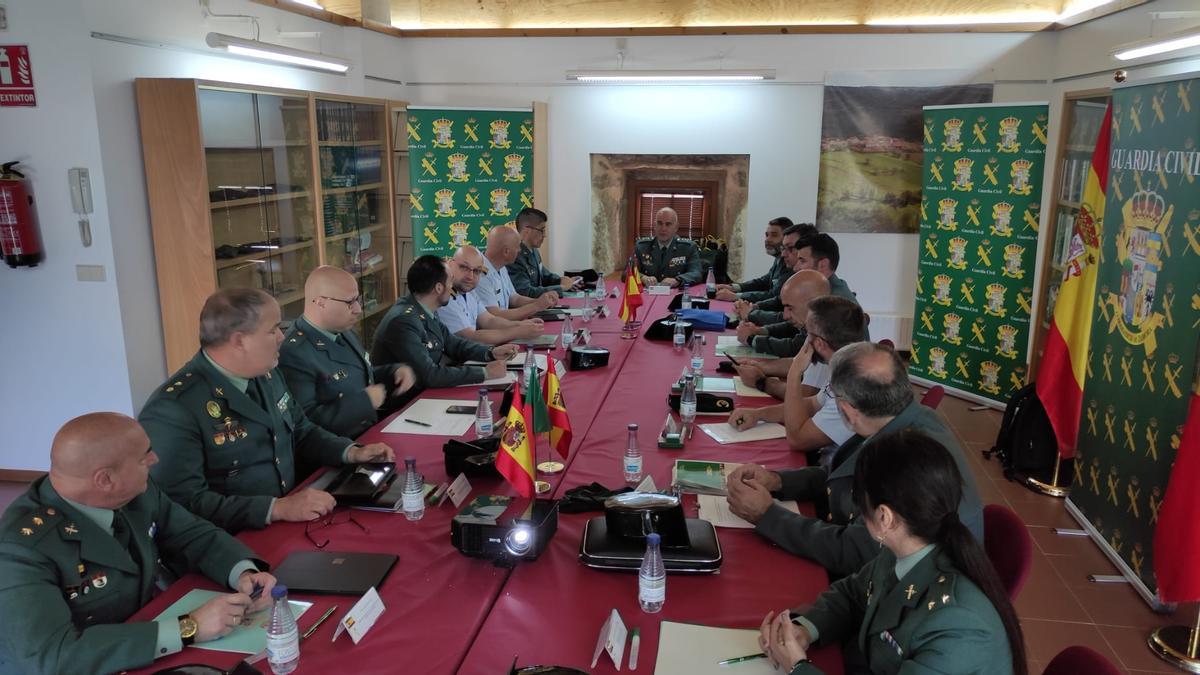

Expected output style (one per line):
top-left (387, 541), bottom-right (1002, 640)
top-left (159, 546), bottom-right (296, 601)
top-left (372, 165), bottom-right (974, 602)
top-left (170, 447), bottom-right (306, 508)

top-left (138, 288), bottom-right (395, 532)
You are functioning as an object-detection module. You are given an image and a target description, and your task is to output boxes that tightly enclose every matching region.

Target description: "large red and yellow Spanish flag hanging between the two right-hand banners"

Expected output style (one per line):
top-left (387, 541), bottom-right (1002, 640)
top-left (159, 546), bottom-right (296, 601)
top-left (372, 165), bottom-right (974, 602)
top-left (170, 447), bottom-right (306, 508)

top-left (1037, 104), bottom-right (1112, 459)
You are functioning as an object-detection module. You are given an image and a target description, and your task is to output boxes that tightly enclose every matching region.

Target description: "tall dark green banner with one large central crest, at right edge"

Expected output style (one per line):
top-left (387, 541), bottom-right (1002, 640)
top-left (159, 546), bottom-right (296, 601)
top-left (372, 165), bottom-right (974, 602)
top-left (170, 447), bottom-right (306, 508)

top-left (1068, 78), bottom-right (1200, 602)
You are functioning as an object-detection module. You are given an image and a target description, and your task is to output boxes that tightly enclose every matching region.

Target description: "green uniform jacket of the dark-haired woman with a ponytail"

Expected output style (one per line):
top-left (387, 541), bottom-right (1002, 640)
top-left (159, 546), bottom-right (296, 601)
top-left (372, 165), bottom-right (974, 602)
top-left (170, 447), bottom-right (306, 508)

top-left (792, 548), bottom-right (1013, 675)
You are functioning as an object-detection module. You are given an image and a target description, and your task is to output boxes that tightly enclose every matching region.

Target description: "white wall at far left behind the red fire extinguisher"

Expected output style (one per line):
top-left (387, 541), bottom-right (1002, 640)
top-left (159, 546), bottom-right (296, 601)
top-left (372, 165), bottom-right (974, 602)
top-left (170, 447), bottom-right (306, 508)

top-left (0, 0), bottom-right (133, 470)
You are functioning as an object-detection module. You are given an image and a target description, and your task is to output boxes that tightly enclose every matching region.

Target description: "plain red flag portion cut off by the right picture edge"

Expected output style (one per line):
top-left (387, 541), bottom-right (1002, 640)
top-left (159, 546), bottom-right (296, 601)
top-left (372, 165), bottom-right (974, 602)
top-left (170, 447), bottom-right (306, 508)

top-left (1154, 377), bottom-right (1200, 603)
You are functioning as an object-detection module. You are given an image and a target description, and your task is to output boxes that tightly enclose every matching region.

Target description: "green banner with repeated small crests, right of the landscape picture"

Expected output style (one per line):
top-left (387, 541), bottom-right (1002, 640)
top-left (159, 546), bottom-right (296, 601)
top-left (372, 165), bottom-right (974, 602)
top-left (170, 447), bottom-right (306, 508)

top-left (908, 103), bottom-right (1048, 407)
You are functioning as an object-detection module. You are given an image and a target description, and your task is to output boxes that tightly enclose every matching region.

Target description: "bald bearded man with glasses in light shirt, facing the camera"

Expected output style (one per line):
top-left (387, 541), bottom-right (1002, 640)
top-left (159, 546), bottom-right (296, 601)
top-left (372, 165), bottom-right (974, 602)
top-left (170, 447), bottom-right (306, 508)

top-left (438, 246), bottom-right (544, 345)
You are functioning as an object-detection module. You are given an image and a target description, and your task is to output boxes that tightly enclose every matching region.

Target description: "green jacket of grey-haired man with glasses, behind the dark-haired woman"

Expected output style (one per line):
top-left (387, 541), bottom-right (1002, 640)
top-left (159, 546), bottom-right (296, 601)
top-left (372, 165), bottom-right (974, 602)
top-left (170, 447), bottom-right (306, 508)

top-left (755, 401), bottom-right (983, 577)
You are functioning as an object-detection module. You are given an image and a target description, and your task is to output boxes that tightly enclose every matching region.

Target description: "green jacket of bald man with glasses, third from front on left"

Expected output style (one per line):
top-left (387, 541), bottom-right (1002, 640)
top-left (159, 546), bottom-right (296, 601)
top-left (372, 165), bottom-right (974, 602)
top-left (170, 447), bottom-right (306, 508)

top-left (280, 317), bottom-right (396, 438)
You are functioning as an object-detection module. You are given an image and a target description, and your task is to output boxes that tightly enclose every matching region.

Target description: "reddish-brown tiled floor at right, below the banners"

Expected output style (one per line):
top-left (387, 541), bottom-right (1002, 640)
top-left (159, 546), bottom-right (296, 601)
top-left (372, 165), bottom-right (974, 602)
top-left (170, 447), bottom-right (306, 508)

top-left (938, 386), bottom-right (1195, 675)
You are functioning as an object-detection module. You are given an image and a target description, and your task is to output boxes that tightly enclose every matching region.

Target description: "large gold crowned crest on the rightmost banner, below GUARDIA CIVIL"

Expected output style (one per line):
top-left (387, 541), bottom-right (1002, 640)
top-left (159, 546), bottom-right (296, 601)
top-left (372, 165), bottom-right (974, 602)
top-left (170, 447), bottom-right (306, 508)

top-left (1102, 190), bottom-right (1175, 357)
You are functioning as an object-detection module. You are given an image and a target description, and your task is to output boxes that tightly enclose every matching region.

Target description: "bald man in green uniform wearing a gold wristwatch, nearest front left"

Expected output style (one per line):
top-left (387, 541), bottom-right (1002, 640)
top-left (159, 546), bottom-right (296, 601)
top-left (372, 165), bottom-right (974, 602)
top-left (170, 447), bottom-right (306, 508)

top-left (0, 413), bottom-right (275, 674)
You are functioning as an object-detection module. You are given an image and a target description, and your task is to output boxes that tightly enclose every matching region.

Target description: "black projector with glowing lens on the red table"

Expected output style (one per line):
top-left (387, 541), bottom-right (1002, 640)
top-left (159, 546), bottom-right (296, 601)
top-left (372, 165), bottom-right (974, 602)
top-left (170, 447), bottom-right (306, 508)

top-left (450, 496), bottom-right (558, 567)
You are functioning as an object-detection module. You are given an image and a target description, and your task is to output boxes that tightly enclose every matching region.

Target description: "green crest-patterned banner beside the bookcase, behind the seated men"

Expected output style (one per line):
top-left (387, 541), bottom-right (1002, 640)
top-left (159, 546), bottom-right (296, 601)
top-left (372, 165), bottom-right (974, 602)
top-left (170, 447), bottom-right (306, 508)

top-left (408, 107), bottom-right (533, 256)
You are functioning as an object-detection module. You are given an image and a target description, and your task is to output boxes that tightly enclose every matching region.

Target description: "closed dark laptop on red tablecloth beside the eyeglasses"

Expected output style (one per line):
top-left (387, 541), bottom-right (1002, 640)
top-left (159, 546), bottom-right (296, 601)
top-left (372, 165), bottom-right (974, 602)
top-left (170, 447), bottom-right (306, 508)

top-left (272, 551), bottom-right (400, 596)
